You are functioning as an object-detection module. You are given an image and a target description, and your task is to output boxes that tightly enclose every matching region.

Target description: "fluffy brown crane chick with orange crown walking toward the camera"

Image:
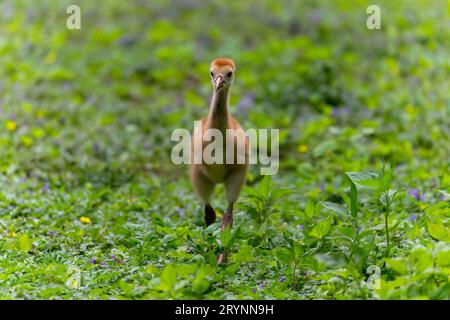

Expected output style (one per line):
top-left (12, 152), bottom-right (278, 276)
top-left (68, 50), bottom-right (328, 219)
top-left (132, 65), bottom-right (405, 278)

top-left (190, 58), bottom-right (249, 230)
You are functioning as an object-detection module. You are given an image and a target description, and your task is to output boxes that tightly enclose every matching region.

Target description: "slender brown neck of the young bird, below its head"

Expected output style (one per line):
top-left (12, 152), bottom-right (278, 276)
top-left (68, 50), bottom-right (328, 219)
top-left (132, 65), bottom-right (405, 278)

top-left (208, 88), bottom-right (230, 130)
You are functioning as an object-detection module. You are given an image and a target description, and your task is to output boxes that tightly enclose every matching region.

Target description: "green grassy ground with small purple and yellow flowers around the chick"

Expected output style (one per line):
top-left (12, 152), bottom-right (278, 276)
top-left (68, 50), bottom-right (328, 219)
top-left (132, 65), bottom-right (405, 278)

top-left (0, 0), bottom-right (450, 299)
